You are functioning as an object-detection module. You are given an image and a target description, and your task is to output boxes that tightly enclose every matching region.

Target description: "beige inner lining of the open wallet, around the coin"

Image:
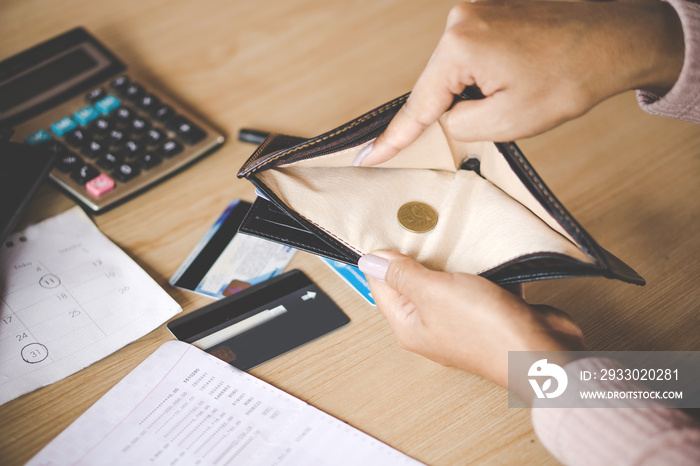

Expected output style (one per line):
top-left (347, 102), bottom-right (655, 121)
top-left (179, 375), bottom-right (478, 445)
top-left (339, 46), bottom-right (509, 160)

top-left (257, 118), bottom-right (593, 273)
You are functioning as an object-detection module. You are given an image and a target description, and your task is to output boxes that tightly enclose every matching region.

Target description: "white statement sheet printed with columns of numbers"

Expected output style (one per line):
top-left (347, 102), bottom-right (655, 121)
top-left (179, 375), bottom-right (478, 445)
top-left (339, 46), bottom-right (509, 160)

top-left (28, 341), bottom-right (420, 466)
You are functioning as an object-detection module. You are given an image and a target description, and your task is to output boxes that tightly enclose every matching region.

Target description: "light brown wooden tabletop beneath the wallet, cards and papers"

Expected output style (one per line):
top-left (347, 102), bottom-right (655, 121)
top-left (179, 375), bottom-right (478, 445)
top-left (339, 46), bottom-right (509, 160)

top-left (0, 0), bottom-right (700, 465)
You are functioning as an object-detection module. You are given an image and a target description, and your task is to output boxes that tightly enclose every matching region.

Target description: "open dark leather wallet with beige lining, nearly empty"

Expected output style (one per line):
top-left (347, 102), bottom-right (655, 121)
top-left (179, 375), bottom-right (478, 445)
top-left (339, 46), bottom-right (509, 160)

top-left (238, 93), bottom-right (645, 285)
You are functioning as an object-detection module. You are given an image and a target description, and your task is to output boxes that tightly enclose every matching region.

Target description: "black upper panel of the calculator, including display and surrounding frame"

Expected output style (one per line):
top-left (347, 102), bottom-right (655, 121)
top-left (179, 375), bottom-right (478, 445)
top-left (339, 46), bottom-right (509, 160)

top-left (0, 28), bottom-right (125, 126)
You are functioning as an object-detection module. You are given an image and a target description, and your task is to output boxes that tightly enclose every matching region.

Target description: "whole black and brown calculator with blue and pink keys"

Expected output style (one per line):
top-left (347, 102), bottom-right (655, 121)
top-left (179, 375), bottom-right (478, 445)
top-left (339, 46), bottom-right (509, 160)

top-left (0, 28), bottom-right (224, 213)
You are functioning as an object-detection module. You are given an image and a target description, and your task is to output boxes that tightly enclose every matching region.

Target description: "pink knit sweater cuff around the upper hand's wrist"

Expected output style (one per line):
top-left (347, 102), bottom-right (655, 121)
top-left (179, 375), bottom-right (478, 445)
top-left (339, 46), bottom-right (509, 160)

top-left (637, 0), bottom-right (700, 124)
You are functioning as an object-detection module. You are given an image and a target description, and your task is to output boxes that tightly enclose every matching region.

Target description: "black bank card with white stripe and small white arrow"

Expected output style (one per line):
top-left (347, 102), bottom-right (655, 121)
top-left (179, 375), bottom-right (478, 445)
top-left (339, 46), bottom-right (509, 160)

top-left (168, 270), bottom-right (350, 370)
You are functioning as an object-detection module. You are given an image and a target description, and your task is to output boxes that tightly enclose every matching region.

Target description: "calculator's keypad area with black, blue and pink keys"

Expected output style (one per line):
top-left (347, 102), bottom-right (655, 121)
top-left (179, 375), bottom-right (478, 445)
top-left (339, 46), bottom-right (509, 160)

top-left (18, 76), bottom-right (221, 211)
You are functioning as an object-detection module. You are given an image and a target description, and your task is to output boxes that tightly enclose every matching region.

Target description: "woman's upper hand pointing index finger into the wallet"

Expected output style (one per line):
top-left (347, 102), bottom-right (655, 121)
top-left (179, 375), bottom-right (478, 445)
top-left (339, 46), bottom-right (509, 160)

top-left (355, 0), bottom-right (684, 166)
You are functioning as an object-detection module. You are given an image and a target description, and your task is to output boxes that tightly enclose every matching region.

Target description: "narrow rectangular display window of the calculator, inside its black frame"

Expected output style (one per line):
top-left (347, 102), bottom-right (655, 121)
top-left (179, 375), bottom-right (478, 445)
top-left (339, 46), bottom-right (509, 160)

top-left (0, 49), bottom-right (97, 113)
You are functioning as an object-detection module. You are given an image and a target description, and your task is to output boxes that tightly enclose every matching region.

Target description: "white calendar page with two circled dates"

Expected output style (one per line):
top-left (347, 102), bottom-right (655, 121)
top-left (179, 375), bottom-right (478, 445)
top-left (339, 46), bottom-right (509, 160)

top-left (0, 207), bottom-right (182, 404)
